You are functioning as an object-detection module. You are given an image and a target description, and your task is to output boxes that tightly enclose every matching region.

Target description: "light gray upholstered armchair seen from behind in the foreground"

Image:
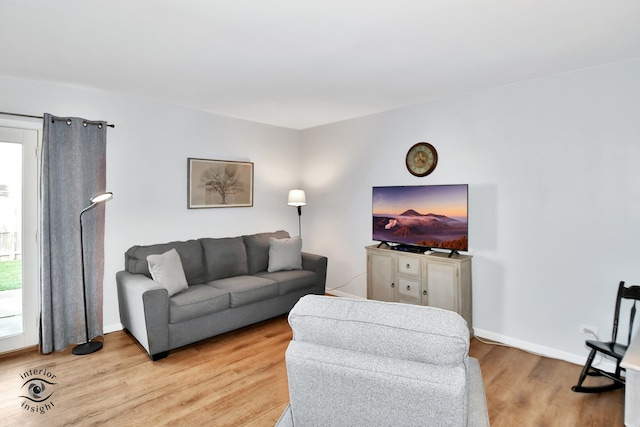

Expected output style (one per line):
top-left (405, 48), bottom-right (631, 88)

top-left (277, 295), bottom-right (489, 427)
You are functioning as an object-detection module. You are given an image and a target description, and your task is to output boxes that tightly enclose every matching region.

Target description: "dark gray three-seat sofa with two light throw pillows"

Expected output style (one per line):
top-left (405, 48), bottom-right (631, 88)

top-left (116, 230), bottom-right (327, 360)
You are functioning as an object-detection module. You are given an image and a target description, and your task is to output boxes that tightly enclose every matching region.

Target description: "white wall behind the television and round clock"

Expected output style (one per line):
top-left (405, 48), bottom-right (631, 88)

top-left (302, 56), bottom-right (640, 362)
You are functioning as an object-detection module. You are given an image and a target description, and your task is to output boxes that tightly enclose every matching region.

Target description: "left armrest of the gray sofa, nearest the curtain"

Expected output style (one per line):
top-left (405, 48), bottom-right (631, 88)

top-left (116, 271), bottom-right (169, 357)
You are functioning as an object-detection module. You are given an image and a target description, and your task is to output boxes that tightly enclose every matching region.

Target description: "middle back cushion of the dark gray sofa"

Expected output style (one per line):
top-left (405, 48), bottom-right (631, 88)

top-left (200, 237), bottom-right (248, 282)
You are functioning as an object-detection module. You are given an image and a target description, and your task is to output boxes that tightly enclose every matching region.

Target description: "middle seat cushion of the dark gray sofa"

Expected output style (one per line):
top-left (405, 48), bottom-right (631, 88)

top-left (208, 276), bottom-right (278, 307)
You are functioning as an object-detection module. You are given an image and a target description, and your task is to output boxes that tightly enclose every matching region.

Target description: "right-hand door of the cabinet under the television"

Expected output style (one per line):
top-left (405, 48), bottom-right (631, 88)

top-left (427, 262), bottom-right (460, 312)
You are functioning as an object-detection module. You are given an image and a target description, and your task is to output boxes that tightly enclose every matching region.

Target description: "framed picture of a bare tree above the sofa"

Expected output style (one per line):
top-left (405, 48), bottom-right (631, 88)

top-left (187, 158), bottom-right (253, 209)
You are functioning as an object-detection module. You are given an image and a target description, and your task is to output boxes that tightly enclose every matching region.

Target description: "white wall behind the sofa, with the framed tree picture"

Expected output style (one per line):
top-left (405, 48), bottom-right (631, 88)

top-left (0, 76), bottom-right (300, 332)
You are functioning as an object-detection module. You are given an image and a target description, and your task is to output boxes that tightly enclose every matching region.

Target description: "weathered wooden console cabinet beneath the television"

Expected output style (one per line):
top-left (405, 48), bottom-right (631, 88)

top-left (366, 246), bottom-right (473, 333)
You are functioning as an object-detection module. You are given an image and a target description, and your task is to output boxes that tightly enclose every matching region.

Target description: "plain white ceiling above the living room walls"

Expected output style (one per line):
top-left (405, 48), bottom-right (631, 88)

top-left (0, 0), bottom-right (640, 129)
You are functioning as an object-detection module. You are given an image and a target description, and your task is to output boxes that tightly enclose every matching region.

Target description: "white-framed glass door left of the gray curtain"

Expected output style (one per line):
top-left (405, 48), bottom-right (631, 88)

top-left (0, 119), bottom-right (42, 353)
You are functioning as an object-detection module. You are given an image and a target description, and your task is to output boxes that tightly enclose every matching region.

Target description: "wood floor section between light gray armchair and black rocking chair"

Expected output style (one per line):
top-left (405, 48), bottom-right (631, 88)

top-left (469, 339), bottom-right (624, 427)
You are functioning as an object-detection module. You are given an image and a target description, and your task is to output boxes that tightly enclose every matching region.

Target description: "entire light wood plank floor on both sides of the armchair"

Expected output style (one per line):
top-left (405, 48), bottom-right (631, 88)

top-left (0, 316), bottom-right (624, 427)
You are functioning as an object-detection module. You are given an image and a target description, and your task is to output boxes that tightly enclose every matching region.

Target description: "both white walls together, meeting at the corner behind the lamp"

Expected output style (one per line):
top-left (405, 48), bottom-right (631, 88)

top-left (0, 56), bottom-right (640, 362)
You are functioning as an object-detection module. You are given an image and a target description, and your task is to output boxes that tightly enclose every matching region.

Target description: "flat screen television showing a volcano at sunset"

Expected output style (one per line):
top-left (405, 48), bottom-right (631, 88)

top-left (372, 184), bottom-right (469, 253)
